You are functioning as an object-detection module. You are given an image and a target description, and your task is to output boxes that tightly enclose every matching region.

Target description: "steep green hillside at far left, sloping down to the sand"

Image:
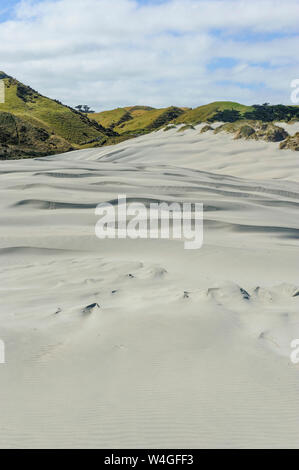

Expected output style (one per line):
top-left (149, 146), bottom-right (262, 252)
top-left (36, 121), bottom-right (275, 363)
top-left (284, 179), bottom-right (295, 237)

top-left (0, 72), bottom-right (116, 158)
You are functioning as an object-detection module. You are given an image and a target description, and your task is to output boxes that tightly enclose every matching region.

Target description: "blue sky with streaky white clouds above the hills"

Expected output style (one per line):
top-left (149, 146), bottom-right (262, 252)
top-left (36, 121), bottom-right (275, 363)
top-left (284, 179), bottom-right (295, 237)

top-left (0, 0), bottom-right (299, 111)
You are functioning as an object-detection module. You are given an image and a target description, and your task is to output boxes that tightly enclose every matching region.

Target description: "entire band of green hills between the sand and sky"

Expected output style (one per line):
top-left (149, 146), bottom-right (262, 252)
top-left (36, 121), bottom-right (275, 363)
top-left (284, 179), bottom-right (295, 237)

top-left (0, 72), bottom-right (299, 159)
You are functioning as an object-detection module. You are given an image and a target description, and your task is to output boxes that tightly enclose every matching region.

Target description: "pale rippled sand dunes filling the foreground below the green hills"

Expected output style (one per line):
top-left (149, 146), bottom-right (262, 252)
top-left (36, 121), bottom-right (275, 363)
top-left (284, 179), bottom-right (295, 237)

top-left (0, 126), bottom-right (299, 448)
